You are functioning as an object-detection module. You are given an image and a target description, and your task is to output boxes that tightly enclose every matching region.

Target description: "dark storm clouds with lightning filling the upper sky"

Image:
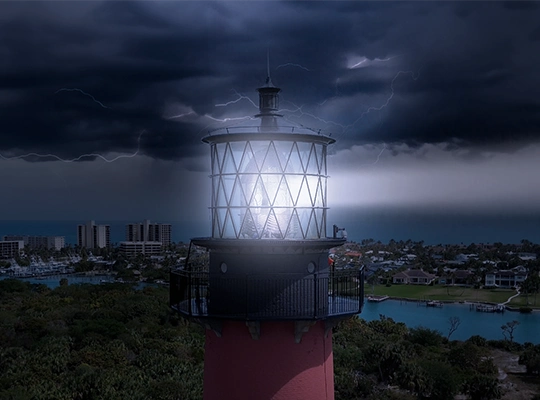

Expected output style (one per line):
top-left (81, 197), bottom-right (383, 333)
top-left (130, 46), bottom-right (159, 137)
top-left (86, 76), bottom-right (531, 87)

top-left (0, 0), bottom-right (540, 163)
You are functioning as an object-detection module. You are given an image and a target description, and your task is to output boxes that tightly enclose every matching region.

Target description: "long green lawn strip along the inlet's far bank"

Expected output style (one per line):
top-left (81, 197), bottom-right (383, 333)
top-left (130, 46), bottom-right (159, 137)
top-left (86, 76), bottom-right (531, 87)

top-left (364, 285), bottom-right (516, 303)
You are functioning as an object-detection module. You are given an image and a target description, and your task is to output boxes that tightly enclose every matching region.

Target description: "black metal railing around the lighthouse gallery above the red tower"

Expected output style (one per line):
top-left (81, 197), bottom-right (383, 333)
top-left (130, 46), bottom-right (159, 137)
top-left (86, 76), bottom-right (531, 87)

top-left (170, 269), bottom-right (364, 320)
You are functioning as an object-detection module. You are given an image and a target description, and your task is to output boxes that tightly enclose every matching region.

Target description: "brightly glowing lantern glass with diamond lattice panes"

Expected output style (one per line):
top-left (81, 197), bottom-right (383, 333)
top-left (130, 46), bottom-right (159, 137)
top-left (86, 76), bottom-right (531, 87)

top-left (211, 140), bottom-right (327, 239)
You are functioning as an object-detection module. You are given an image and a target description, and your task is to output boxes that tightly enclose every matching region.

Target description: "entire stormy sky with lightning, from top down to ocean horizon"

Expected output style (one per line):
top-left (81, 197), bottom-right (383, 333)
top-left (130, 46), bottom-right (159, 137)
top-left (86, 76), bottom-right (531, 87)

top-left (0, 0), bottom-right (540, 227)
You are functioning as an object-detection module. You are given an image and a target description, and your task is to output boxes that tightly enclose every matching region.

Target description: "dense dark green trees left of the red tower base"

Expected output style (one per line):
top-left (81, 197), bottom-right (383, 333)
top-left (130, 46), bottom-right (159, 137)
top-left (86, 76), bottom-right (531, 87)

top-left (0, 280), bottom-right (204, 400)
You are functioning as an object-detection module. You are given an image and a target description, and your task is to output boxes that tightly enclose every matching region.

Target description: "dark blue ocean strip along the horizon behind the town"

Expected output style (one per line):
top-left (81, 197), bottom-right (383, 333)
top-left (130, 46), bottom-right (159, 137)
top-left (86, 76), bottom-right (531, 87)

top-left (0, 209), bottom-right (540, 244)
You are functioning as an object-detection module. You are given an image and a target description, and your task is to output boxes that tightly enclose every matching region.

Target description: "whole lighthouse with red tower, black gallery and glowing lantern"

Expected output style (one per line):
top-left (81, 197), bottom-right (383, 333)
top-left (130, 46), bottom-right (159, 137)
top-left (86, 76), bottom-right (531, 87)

top-left (170, 72), bottom-right (363, 400)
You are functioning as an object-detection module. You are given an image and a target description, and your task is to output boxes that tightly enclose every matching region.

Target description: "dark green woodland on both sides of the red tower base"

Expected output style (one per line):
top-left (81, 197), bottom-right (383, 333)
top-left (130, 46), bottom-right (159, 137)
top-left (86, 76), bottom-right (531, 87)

top-left (0, 280), bottom-right (540, 400)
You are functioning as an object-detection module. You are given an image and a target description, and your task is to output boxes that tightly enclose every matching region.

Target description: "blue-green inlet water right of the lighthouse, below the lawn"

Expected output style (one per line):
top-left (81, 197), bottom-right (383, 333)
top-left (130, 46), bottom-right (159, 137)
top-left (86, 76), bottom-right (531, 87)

top-left (359, 300), bottom-right (540, 344)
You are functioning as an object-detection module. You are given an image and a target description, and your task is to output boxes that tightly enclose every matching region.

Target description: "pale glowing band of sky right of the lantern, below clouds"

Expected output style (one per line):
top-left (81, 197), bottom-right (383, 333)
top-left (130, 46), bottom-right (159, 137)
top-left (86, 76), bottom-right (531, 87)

top-left (328, 141), bottom-right (540, 212)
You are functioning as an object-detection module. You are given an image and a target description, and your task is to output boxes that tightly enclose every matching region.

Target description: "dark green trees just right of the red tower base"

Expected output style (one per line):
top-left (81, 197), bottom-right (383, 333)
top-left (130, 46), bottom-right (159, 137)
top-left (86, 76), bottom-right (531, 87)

top-left (334, 316), bottom-right (504, 400)
